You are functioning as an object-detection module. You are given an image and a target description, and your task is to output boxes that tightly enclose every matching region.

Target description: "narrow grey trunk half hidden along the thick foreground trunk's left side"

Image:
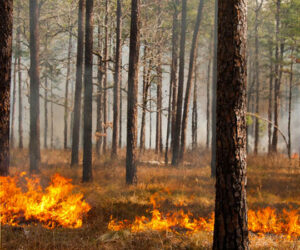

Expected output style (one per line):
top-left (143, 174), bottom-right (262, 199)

top-left (210, 0), bottom-right (218, 177)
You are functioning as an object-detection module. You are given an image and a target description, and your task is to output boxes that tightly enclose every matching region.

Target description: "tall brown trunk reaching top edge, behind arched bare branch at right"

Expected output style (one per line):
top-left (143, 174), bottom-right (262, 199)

top-left (272, 0), bottom-right (281, 153)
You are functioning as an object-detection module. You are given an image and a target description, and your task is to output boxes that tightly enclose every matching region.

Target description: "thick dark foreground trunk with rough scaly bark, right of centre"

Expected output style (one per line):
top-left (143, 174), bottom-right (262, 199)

top-left (213, 0), bottom-right (249, 249)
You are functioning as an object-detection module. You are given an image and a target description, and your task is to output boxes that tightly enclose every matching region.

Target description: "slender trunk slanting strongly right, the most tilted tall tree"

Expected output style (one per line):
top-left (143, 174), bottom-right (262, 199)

top-left (180, 0), bottom-right (204, 159)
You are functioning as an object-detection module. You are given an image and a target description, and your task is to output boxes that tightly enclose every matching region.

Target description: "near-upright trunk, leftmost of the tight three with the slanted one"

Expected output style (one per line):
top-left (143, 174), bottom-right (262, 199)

top-left (170, 0), bottom-right (179, 149)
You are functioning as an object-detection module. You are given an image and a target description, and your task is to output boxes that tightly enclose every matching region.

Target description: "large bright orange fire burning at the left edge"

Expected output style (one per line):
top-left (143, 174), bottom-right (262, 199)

top-left (0, 172), bottom-right (91, 229)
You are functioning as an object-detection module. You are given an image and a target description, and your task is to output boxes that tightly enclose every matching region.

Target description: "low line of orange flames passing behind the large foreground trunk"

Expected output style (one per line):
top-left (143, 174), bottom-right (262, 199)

top-left (108, 194), bottom-right (300, 239)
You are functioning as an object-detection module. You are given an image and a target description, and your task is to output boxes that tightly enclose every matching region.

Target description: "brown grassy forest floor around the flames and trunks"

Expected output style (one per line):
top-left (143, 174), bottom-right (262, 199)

top-left (0, 150), bottom-right (300, 250)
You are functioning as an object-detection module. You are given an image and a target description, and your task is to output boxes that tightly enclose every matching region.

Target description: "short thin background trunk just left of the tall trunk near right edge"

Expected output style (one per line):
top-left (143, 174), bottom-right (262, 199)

top-left (268, 42), bottom-right (273, 154)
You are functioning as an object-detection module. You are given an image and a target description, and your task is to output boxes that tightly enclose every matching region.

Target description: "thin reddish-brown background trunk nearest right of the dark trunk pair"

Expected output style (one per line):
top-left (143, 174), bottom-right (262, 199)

top-left (96, 22), bottom-right (103, 157)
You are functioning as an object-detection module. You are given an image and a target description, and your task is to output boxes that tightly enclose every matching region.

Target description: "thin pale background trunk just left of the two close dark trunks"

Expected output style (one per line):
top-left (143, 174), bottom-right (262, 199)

top-left (64, 28), bottom-right (72, 150)
